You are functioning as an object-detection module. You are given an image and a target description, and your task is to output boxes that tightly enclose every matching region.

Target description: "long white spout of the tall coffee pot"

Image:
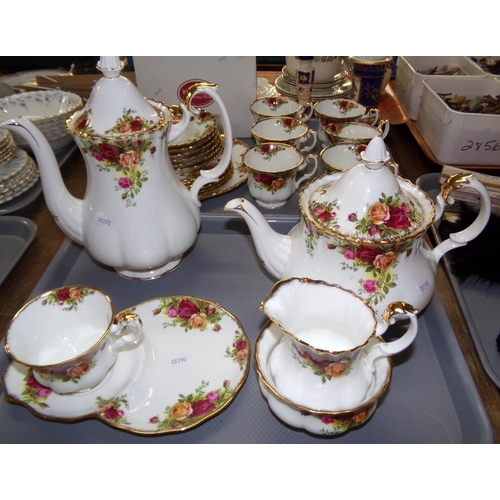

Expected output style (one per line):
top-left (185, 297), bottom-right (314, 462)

top-left (0, 117), bottom-right (83, 244)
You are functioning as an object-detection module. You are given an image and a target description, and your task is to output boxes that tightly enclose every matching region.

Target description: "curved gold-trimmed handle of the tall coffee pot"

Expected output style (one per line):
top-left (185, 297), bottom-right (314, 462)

top-left (184, 82), bottom-right (233, 206)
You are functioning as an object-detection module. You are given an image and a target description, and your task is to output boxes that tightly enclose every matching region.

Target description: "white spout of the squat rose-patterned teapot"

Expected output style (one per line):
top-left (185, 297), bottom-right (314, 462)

top-left (224, 198), bottom-right (292, 279)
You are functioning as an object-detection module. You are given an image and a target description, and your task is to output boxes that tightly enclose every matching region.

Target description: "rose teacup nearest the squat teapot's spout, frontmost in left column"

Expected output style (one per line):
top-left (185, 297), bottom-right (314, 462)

top-left (242, 143), bottom-right (318, 208)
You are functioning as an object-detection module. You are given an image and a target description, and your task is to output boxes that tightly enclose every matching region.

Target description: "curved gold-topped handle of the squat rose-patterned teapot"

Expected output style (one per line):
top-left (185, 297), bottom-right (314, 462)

top-left (421, 172), bottom-right (491, 264)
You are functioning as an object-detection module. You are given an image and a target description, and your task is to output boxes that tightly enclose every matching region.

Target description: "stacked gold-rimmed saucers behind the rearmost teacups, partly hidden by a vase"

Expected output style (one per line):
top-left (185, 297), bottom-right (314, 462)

top-left (275, 66), bottom-right (352, 102)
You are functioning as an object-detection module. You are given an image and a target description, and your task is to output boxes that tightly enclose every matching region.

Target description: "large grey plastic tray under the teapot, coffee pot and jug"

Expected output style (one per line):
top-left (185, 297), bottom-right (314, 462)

top-left (0, 215), bottom-right (493, 444)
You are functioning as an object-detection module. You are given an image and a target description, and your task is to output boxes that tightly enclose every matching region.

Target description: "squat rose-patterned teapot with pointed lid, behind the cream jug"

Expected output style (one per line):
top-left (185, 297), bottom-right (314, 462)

top-left (225, 137), bottom-right (491, 318)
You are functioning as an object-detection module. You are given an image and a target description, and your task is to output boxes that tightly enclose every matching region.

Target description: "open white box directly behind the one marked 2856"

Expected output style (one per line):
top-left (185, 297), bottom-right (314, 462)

top-left (395, 56), bottom-right (486, 120)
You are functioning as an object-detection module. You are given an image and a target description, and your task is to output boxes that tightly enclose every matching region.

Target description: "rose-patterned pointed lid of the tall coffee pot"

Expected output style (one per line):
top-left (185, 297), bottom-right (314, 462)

top-left (71, 56), bottom-right (164, 137)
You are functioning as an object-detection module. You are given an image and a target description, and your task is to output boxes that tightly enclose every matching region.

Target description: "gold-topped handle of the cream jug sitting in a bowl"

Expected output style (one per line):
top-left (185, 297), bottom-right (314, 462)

top-left (365, 302), bottom-right (418, 372)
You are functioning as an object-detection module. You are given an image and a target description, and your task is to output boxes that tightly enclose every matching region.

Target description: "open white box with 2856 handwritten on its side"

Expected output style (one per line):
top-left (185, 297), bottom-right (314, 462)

top-left (416, 77), bottom-right (500, 166)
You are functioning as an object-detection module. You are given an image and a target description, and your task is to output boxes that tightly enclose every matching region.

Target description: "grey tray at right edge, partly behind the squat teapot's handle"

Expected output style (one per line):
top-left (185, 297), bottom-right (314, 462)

top-left (417, 173), bottom-right (500, 388)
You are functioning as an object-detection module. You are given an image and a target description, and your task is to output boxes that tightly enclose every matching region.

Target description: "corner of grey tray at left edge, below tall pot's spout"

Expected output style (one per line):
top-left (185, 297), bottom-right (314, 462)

top-left (0, 215), bottom-right (36, 285)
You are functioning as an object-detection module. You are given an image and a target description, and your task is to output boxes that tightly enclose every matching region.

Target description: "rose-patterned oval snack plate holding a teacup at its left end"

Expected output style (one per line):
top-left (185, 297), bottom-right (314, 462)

top-left (2, 296), bottom-right (251, 434)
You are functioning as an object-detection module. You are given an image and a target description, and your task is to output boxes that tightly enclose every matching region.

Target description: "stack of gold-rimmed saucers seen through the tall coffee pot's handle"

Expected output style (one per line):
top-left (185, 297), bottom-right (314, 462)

top-left (168, 106), bottom-right (233, 194)
